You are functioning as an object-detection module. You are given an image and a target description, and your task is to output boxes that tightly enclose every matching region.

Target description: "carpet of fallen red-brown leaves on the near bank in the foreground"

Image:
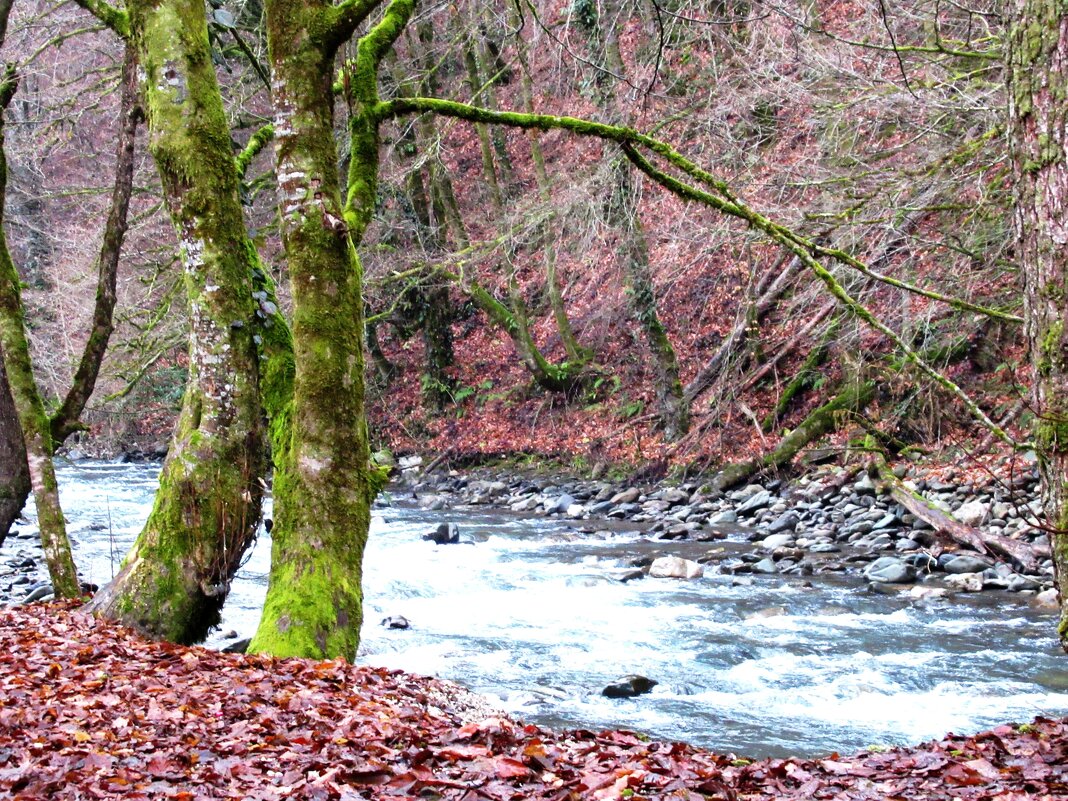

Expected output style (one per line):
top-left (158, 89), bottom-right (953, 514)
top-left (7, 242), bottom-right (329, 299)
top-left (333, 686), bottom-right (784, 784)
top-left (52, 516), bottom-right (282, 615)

top-left (0, 604), bottom-right (1068, 801)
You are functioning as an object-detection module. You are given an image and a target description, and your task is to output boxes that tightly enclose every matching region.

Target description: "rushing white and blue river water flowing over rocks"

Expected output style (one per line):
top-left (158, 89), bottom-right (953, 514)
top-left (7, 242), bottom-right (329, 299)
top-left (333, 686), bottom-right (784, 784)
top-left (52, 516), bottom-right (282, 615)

top-left (39, 461), bottom-right (1068, 756)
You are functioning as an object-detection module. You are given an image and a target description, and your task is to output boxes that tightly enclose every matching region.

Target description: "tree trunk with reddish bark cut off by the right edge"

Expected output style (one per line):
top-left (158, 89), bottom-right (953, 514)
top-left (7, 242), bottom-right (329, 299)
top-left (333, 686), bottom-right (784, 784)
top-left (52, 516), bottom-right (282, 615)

top-left (1008, 0), bottom-right (1068, 650)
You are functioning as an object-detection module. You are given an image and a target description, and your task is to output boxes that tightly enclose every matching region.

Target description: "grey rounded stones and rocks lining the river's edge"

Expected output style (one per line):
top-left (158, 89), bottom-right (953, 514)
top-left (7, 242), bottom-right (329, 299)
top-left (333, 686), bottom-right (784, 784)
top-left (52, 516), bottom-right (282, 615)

top-left (0, 456), bottom-right (1056, 609)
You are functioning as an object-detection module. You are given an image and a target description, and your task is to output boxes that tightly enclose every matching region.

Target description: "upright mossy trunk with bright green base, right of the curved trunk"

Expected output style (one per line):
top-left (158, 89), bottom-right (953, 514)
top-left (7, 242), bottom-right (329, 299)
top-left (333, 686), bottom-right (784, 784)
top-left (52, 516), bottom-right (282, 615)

top-left (249, 0), bottom-right (414, 660)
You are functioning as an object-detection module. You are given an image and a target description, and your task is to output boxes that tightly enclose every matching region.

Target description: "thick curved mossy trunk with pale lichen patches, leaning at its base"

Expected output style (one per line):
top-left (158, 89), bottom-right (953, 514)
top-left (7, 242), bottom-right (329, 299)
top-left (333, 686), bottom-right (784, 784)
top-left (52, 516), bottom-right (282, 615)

top-left (75, 0), bottom-right (265, 643)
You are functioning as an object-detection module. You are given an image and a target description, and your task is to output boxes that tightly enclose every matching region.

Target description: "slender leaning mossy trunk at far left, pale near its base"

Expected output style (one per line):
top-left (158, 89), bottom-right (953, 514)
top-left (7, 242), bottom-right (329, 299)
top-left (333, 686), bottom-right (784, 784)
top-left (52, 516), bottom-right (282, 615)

top-left (0, 65), bottom-right (79, 598)
